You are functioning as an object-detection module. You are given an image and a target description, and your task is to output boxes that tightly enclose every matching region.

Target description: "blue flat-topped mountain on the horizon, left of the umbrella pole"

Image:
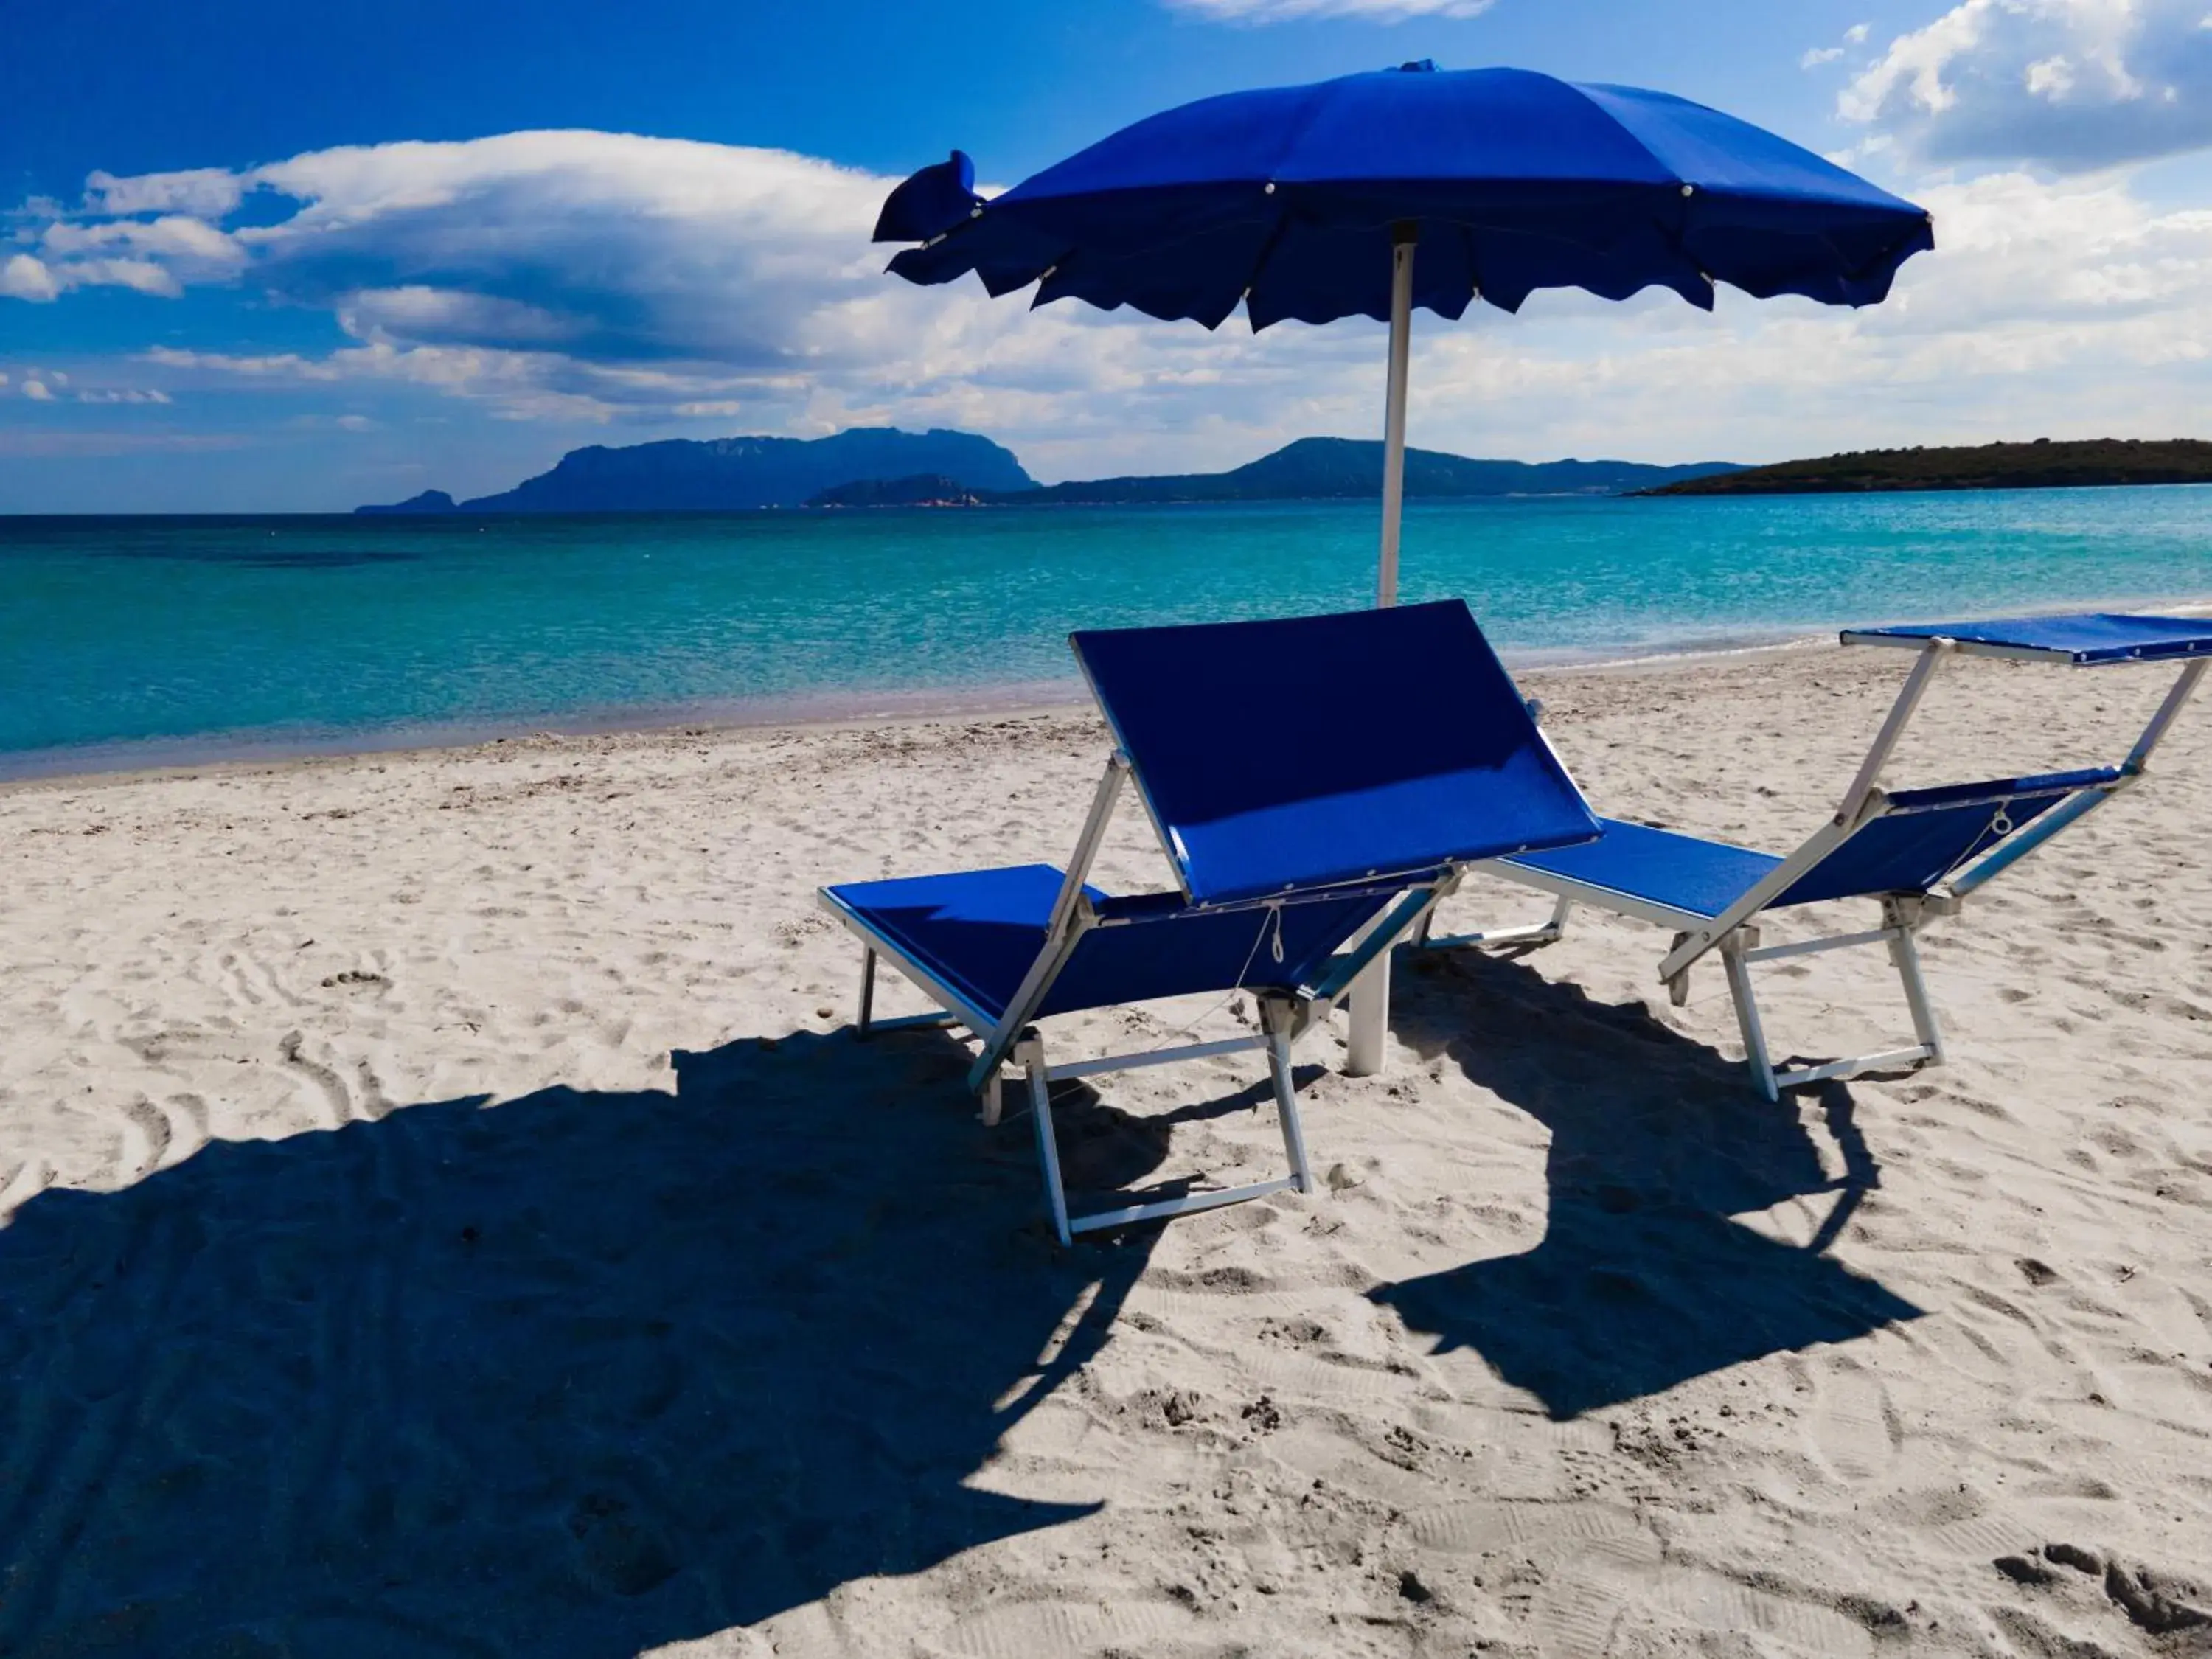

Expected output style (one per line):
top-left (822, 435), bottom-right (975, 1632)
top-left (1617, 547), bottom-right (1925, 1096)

top-left (356, 427), bottom-right (1035, 513)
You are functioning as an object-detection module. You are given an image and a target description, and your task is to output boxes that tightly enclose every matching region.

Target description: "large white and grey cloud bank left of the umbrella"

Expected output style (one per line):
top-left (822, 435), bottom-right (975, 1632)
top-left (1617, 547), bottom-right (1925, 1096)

top-left (17, 133), bottom-right (1048, 418)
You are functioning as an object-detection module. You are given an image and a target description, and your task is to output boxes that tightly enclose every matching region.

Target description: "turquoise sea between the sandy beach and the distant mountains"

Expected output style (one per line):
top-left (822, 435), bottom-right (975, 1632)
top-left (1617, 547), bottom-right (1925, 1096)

top-left (13, 487), bottom-right (2212, 776)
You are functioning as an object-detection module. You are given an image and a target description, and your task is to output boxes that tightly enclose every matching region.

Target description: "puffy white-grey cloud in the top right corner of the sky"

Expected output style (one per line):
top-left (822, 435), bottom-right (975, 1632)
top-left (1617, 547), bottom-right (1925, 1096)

top-left (1838, 0), bottom-right (2212, 173)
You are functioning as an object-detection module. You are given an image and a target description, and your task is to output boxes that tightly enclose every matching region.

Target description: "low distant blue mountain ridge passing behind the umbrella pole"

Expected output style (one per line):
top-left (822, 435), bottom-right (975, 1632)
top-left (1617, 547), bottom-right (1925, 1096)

top-left (998, 438), bottom-right (1732, 504)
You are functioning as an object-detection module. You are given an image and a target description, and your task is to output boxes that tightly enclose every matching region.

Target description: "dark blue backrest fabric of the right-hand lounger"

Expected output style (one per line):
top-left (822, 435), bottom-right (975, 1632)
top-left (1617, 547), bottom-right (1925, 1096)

top-left (1770, 765), bottom-right (2121, 909)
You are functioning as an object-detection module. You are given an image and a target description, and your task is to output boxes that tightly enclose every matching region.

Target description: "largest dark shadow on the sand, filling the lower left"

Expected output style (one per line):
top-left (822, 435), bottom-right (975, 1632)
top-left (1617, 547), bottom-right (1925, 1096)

top-left (0, 1033), bottom-right (1157, 1659)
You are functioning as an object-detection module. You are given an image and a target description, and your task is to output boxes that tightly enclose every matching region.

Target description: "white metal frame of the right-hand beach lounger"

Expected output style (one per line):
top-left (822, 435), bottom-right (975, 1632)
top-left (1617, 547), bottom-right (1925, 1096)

top-left (1422, 633), bottom-right (2212, 1099)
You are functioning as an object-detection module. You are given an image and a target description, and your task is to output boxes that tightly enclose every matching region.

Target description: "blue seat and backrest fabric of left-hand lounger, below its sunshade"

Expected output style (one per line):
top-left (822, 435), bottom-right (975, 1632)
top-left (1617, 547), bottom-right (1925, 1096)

top-left (825, 865), bottom-right (1394, 1020)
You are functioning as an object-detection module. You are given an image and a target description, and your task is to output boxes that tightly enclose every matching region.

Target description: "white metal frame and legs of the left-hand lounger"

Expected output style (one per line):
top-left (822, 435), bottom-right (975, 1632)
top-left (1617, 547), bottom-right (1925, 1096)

top-left (821, 752), bottom-right (1460, 1245)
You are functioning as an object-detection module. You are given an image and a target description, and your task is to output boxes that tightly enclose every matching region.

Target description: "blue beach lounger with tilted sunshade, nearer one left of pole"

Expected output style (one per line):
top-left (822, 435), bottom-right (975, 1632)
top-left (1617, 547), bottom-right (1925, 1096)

top-left (821, 602), bottom-right (1597, 1243)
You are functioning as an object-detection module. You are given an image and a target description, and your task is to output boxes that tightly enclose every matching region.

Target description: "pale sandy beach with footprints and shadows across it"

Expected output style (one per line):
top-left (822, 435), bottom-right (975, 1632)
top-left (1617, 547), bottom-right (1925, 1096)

top-left (0, 650), bottom-right (2212, 1659)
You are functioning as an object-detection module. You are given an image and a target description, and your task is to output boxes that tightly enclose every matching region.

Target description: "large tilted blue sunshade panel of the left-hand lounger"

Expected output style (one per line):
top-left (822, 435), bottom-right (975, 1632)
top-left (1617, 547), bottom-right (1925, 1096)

top-left (1071, 599), bottom-right (1597, 905)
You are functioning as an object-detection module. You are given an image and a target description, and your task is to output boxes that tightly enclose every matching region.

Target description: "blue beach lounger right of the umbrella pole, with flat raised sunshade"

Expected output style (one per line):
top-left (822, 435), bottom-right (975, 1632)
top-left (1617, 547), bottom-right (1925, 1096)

top-left (1420, 615), bottom-right (2212, 1099)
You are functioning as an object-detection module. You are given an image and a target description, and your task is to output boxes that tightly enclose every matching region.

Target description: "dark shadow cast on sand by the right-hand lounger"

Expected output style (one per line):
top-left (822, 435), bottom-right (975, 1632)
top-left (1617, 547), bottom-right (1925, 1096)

top-left (1371, 953), bottom-right (1922, 1418)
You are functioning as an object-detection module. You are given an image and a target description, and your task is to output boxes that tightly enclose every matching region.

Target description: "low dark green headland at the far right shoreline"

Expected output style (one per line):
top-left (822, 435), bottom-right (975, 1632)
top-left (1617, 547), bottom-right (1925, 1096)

top-left (1637, 438), bottom-right (2212, 495)
